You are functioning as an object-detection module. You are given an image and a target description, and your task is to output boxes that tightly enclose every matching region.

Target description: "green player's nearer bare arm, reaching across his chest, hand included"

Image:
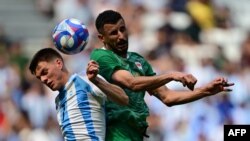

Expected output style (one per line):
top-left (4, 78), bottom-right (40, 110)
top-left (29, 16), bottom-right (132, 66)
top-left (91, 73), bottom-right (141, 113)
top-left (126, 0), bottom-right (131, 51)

top-left (112, 70), bottom-right (197, 91)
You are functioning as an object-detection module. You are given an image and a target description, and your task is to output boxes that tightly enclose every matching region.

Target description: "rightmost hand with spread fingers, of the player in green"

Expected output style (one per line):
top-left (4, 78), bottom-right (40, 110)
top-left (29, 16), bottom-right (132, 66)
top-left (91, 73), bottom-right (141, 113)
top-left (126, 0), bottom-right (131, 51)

top-left (202, 77), bottom-right (234, 95)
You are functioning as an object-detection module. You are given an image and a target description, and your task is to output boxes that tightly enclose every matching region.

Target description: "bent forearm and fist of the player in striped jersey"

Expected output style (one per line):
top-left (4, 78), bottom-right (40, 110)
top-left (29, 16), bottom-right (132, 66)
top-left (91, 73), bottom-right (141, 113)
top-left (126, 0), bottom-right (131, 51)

top-left (87, 61), bottom-right (129, 105)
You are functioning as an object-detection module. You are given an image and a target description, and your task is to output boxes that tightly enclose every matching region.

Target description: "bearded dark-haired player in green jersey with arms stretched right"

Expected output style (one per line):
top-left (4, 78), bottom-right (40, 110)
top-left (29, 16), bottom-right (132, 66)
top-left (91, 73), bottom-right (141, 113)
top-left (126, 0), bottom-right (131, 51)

top-left (91, 10), bottom-right (233, 141)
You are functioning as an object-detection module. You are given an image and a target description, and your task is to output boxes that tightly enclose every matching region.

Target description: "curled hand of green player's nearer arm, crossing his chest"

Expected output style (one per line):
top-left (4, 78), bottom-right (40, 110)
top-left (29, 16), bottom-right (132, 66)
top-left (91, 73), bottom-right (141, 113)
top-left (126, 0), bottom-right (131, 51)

top-left (173, 72), bottom-right (197, 90)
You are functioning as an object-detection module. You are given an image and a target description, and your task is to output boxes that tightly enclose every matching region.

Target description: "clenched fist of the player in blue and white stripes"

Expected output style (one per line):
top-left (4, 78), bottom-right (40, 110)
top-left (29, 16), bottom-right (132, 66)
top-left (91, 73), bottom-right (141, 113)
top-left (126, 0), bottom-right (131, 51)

top-left (86, 60), bottom-right (99, 81)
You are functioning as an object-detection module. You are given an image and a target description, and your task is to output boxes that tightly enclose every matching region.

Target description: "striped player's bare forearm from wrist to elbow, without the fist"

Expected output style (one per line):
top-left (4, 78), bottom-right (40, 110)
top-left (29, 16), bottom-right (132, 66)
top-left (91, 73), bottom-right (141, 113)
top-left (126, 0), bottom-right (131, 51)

top-left (90, 76), bottom-right (128, 105)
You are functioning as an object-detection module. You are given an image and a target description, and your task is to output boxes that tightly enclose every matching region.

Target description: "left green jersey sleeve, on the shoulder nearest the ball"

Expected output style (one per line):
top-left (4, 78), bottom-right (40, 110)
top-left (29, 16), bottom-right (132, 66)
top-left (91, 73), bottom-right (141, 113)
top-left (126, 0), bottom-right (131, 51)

top-left (90, 49), bottom-right (125, 82)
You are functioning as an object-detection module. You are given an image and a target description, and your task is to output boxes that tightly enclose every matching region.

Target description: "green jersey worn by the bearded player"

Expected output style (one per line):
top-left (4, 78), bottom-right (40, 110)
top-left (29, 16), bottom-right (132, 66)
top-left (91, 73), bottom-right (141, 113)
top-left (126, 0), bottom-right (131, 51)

top-left (90, 49), bottom-right (155, 141)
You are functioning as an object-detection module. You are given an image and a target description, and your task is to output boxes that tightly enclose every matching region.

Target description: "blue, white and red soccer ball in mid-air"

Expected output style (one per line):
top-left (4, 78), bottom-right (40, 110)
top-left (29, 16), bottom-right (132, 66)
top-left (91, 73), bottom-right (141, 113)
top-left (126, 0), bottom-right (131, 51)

top-left (52, 18), bottom-right (89, 55)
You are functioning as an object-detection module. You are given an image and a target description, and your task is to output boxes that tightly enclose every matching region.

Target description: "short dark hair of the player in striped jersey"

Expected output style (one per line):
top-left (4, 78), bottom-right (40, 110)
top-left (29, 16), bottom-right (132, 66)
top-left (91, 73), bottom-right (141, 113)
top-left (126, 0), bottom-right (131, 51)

top-left (29, 48), bottom-right (63, 74)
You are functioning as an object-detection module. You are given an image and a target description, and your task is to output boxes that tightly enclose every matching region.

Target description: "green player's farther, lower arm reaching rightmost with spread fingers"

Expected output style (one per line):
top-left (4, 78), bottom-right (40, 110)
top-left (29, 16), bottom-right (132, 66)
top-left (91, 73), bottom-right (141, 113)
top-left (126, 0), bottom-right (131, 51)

top-left (149, 77), bottom-right (234, 106)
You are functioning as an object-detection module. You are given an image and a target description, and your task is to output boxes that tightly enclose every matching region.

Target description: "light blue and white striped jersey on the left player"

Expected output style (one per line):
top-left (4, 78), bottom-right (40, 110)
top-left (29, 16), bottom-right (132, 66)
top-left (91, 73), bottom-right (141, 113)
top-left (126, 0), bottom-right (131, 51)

top-left (56, 74), bottom-right (106, 141)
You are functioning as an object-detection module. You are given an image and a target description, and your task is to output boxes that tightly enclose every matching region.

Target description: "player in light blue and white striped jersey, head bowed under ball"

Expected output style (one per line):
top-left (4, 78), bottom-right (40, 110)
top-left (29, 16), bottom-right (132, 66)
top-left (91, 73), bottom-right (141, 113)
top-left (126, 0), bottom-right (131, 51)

top-left (29, 48), bottom-right (128, 141)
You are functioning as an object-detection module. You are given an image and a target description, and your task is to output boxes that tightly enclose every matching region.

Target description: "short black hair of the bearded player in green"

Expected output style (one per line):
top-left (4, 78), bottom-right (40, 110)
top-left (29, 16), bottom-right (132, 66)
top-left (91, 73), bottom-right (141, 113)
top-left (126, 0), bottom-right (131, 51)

top-left (95, 10), bottom-right (123, 33)
